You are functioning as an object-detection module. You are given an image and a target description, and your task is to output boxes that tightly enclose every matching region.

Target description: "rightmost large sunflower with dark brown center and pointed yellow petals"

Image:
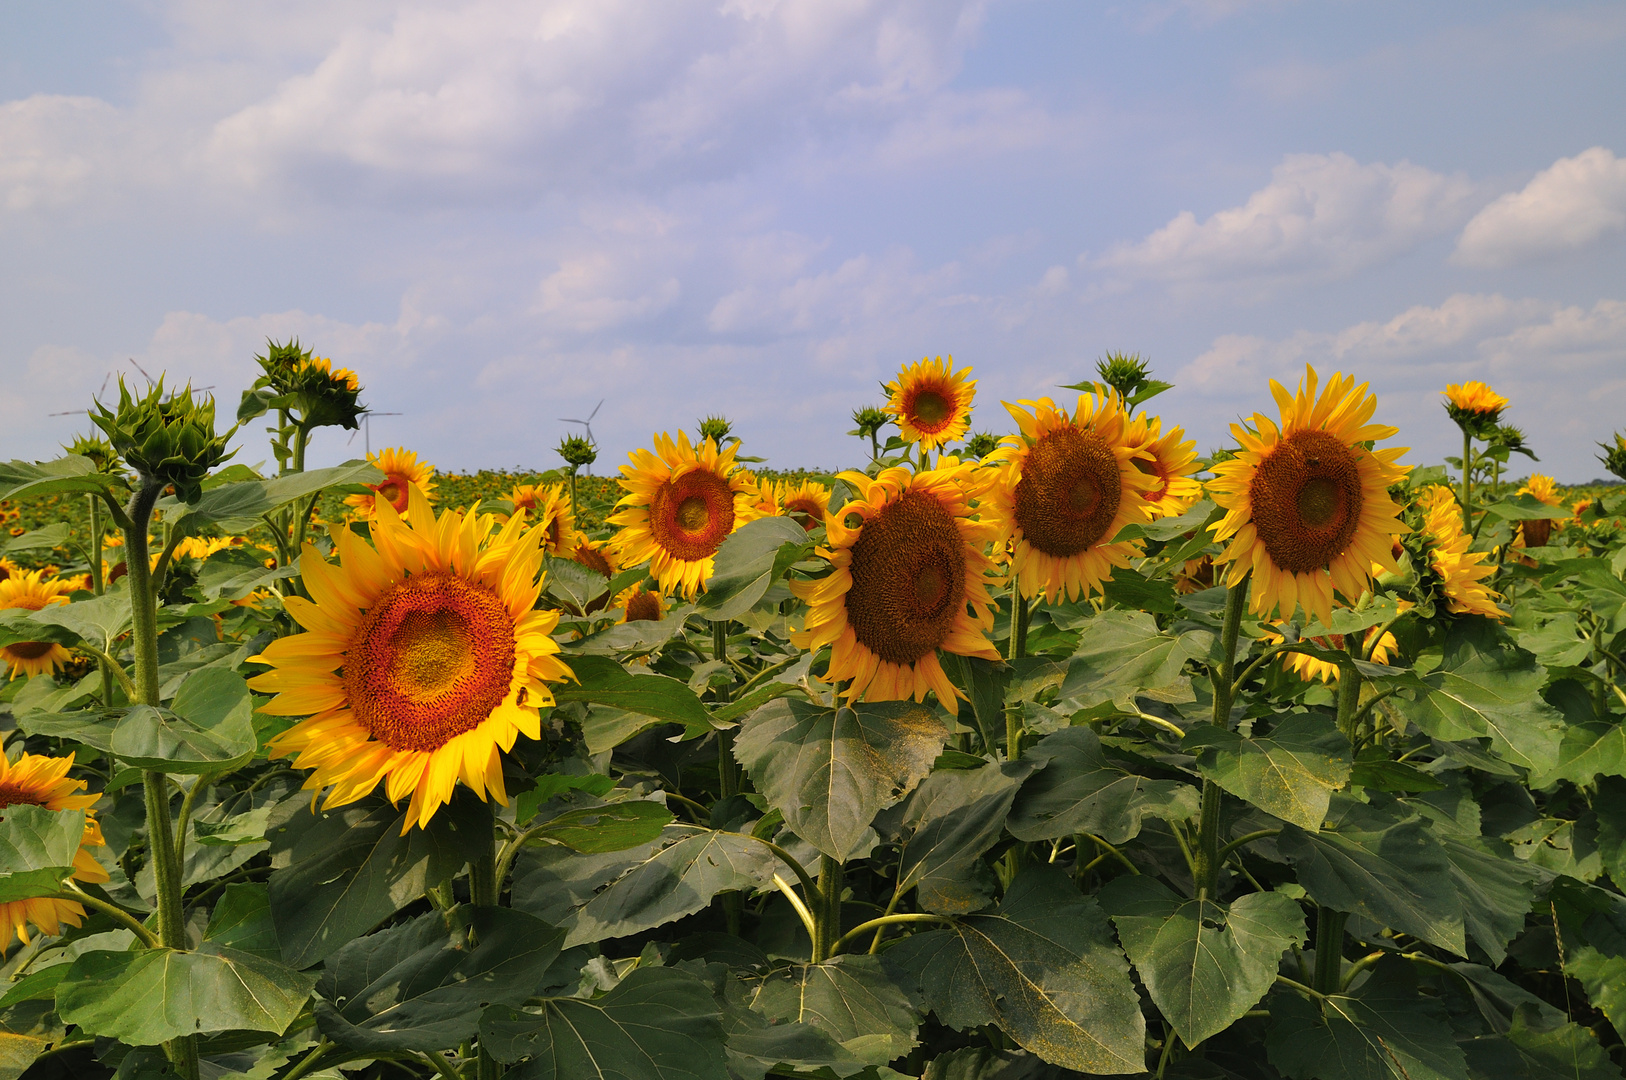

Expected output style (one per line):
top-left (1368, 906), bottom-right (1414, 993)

top-left (1208, 366), bottom-right (1408, 623)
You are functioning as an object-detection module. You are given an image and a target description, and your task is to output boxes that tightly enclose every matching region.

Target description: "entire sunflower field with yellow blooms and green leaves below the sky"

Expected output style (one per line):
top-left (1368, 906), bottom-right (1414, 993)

top-left (0, 343), bottom-right (1626, 1080)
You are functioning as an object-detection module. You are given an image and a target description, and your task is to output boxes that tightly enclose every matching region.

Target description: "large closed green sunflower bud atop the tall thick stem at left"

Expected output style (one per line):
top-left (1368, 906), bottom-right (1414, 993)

top-left (91, 379), bottom-right (236, 503)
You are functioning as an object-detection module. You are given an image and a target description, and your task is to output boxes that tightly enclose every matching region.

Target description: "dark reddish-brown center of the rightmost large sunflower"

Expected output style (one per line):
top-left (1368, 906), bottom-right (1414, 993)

top-left (1247, 431), bottom-right (1364, 574)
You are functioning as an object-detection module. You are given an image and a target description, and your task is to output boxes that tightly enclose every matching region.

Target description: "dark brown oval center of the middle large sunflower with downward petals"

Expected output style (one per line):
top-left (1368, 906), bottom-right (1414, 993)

top-left (847, 491), bottom-right (966, 664)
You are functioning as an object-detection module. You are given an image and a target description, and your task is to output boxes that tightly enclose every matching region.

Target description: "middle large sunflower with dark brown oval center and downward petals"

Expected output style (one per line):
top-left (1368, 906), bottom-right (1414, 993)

top-left (790, 457), bottom-right (1000, 712)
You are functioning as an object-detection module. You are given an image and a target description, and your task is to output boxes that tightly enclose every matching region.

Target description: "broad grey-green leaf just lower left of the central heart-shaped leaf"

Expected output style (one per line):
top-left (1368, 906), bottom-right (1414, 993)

top-left (561, 825), bottom-right (777, 948)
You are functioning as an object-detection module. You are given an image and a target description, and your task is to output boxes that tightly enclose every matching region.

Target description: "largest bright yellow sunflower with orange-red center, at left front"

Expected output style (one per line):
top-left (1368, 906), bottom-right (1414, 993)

top-left (249, 485), bottom-right (571, 833)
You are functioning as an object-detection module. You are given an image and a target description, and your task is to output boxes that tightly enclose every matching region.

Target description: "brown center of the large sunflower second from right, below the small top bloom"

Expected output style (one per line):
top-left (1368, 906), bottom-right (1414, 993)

top-left (1015, 428), bottom-right (1124, 558)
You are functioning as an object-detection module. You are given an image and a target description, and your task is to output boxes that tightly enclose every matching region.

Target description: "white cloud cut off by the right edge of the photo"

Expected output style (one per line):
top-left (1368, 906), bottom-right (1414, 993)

top-left (1452, 146), bottom-right (1626, 267)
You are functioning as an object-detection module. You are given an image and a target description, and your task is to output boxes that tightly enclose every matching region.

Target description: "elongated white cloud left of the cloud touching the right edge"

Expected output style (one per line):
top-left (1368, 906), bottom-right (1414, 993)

top-left (1096, 153), bottom-right (1475, 283)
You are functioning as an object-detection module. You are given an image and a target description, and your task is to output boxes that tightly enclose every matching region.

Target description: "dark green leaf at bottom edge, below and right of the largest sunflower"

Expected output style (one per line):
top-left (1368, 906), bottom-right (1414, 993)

top-left (480, 968), bottom-right (728, 1080)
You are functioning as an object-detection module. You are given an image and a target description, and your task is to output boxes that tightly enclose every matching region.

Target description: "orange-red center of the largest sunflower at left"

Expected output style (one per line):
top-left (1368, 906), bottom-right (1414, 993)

top-left (343, 573), bottom-right (514, 750)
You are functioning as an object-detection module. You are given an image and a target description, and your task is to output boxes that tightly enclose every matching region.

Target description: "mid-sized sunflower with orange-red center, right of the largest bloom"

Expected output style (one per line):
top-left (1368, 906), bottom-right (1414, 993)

top-left (610, 431), bottom-right (763, 597)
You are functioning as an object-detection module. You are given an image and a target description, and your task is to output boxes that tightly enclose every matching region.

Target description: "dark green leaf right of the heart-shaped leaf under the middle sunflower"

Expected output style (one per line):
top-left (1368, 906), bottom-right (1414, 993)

top-left (1005, 727), bottom-right (1200, 844)
